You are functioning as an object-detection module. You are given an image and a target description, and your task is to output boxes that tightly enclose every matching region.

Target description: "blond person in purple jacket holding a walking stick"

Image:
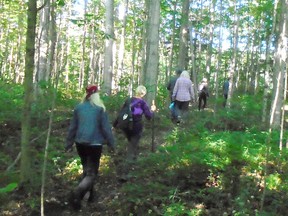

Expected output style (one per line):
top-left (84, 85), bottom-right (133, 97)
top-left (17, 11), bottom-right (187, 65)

top-left (113, 85), bottom-right (156, 162)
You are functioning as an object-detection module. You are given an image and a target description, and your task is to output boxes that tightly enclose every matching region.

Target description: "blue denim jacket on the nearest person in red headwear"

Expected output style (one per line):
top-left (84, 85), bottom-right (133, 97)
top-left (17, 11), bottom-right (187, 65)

top-left (66, 101), bottom-right (115, 148)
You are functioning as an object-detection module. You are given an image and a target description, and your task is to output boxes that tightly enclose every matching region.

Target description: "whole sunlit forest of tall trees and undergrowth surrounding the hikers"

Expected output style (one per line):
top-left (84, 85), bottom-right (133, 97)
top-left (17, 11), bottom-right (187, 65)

top-left (0, 0), bottom-right (288, 216)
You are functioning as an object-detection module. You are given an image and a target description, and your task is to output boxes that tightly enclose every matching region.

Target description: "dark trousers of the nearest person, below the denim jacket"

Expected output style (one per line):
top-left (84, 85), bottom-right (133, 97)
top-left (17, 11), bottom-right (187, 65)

top-left (75, 143), bottom-right (102, 200)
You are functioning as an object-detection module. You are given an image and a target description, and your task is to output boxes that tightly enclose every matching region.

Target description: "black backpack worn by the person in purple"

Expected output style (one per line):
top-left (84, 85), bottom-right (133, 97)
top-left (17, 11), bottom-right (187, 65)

top-left (116, 98), bottom-right (133, 129)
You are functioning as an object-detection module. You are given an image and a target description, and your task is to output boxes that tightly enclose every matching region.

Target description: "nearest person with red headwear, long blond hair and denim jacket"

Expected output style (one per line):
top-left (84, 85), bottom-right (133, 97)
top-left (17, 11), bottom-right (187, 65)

top-left (65, 85), bottom-right (115, 210)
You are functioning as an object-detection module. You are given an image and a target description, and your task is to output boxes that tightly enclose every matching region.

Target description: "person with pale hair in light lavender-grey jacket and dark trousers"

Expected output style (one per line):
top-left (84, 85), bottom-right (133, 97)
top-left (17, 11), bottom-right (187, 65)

top-left (172, 70), bottom-right (195, 123)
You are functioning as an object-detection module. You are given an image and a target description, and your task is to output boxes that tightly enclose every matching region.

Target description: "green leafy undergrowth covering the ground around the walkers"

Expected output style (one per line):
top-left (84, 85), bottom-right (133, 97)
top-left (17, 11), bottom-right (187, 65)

top-left (0, 83), bottom-right (288, 216)
